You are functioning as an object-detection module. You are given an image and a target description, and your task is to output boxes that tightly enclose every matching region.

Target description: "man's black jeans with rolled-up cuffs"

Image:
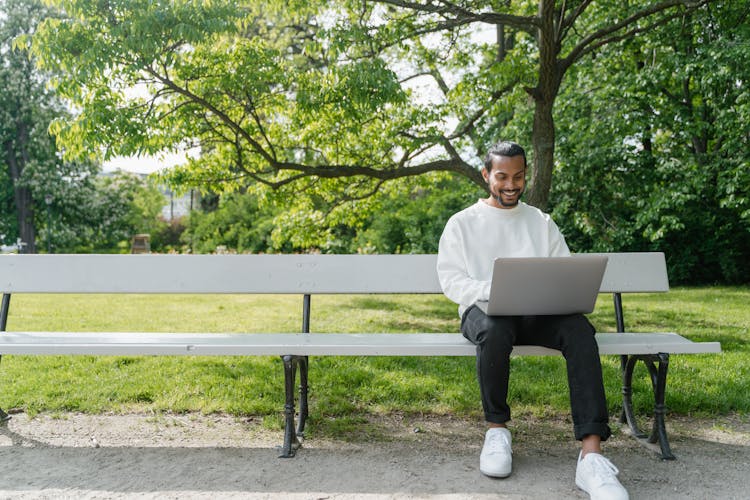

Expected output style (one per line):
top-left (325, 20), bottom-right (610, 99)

top-left (461, 306), bottom-right (611, 440)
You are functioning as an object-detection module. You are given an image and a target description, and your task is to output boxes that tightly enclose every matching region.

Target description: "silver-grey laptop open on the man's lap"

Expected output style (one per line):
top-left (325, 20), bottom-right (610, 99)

top-left (477, 254), bottom-right (607, 316)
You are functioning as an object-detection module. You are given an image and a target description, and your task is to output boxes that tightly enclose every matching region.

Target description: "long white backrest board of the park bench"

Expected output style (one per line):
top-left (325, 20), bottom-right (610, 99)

top-left (0, 253), bottom-right (669, 294)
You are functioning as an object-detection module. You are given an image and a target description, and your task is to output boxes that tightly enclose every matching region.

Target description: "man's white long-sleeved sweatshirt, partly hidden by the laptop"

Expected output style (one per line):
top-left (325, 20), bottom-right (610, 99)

top-left (437, 199), bottom-right (570, 314)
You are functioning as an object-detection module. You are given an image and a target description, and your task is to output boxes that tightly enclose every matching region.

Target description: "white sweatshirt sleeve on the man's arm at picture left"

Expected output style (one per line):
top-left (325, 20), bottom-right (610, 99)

top-left (437, 219), bottom-right (490, 308)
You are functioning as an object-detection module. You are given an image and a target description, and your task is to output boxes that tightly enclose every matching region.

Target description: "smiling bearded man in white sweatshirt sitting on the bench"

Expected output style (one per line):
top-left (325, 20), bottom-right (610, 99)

top-left (437, 142), bottom-right (628, 499)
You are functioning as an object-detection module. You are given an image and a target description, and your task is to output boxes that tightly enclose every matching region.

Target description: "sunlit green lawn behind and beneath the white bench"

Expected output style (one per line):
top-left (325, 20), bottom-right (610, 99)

top-left (0, 287), bottom-right (750, 433)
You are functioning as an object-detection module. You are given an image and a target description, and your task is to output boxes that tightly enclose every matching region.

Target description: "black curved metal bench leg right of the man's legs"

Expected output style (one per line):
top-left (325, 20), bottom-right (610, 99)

top-left (621, 353), bottom-right (675, 460)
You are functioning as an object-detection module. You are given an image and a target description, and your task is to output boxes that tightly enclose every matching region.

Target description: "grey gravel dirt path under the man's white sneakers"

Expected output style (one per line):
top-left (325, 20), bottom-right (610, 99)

top-left (0, 414), bottom-right (750, 500)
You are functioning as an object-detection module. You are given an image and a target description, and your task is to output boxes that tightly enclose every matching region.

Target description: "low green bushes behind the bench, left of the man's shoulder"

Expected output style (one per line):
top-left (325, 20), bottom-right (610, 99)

top-left (182, 174), bottom-right (482, 253)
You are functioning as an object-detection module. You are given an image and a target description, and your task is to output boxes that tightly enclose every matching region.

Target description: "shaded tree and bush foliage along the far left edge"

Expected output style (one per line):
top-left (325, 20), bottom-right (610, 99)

top-left (0, 0), bottom-right (164, 253)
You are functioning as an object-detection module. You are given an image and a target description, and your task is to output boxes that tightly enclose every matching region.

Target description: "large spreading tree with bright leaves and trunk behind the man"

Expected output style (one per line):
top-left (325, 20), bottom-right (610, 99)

top-left (29, 0), bottom-right (710, 213)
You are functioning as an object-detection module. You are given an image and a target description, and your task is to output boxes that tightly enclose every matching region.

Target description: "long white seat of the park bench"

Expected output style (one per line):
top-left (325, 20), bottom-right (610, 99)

top-left (0, 332), bottom-right (721, 356)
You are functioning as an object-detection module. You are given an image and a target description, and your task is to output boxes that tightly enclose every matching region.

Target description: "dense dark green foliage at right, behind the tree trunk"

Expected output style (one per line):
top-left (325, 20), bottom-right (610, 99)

top-left (553, 1), bottom-right (750, 283)
